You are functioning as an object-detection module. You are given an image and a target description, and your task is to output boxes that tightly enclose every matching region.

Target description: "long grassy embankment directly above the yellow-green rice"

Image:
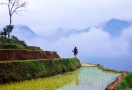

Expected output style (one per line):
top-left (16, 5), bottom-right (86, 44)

top-left (0, 58), bottom-right (80, 84)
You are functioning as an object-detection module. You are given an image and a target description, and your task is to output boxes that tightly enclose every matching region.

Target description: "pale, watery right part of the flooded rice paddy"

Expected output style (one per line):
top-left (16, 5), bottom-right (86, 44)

top-left (58, 67), bottom-right (120, 90)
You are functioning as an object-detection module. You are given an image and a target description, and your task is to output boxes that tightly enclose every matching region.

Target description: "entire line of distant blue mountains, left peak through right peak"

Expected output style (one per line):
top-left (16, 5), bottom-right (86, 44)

top-left (12, 18), bottom-right (132, 41)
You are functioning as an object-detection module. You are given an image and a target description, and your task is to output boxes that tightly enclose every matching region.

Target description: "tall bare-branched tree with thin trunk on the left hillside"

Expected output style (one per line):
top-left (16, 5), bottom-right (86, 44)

top-left (0, 0), bottom-right (28, 38)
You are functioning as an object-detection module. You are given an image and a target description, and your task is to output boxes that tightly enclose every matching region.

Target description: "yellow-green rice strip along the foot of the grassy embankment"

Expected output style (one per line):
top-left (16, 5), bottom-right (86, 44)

top-left (0, 65), bottom-right (80, 90)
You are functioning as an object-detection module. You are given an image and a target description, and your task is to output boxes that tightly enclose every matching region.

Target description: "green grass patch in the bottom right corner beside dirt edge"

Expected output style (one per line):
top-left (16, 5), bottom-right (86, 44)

top-left (115, 72), bottom-right (132, 90)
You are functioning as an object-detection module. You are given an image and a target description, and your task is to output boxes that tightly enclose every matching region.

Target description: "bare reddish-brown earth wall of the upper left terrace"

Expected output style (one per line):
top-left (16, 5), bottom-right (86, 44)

top-left (0, 50), bottom-right (60, 61)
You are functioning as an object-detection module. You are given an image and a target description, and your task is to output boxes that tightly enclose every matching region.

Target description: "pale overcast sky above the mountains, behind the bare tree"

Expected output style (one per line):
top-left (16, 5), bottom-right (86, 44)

top-left (0, 0), bottom-right (132, 35)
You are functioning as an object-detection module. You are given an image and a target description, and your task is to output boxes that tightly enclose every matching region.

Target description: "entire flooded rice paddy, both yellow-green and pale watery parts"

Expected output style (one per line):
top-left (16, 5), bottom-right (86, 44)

top-left (0, 67), bottom-right (120, 90)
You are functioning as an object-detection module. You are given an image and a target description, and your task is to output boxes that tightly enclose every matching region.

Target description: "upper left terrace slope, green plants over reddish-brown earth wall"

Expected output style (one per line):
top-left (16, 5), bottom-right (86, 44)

top-left (0, 36), bottom-right (60, 61)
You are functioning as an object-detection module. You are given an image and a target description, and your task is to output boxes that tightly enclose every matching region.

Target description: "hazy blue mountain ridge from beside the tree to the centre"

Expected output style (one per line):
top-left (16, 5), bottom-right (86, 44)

top-left (11, 24), bottom-right (90, 41)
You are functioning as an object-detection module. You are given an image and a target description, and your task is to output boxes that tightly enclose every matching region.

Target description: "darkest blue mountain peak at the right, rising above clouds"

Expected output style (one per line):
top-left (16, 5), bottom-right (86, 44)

top-left (103, 18), bottom-right (132, 36)
